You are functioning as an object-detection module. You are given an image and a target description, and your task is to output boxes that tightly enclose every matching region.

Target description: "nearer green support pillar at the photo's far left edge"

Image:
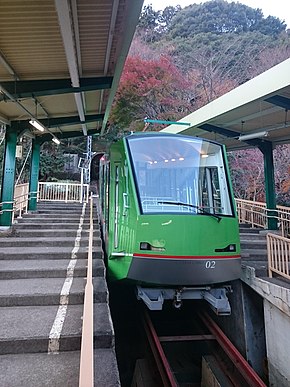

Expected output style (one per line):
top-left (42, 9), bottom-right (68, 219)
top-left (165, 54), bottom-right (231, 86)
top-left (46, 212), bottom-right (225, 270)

top-left (0, 127), bottom-right (17, 227)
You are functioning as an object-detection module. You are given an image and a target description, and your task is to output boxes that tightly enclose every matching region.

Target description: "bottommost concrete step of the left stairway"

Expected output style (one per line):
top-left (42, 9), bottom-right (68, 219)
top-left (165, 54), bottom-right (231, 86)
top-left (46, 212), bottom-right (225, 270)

top-left (0, 348), bottom-right (120, 387)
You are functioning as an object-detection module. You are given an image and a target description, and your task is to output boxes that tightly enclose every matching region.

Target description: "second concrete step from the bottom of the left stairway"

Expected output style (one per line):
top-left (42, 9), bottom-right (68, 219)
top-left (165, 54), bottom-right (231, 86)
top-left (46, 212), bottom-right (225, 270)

top-left (0, 303), bottom-right (114, 355)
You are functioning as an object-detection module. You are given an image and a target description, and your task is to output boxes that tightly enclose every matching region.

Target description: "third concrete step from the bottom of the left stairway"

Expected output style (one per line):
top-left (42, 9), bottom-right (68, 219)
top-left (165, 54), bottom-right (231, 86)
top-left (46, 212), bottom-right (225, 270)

top-left (0, 277), bottom-right (108, 308)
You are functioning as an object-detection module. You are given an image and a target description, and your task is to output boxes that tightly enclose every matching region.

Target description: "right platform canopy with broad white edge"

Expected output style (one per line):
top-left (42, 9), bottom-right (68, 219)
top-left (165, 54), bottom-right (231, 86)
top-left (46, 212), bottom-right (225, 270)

top-left (163, 59), bottom-right (290, 150)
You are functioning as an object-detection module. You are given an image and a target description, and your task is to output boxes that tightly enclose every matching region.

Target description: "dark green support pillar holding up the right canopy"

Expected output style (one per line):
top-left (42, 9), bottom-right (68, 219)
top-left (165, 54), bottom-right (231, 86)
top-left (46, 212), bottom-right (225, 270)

top-left (259, 142), bottom-right (278, 230)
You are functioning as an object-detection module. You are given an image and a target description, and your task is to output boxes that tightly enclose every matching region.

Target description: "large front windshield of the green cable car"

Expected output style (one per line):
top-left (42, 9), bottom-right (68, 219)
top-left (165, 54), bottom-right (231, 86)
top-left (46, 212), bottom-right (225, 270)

top-left (128, 135), bottom-right (233, 217)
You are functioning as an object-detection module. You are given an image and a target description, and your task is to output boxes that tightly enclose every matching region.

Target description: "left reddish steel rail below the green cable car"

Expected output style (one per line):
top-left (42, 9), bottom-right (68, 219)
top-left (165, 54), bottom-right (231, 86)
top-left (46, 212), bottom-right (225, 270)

top-left (143, 310), bottom-right (178, 387)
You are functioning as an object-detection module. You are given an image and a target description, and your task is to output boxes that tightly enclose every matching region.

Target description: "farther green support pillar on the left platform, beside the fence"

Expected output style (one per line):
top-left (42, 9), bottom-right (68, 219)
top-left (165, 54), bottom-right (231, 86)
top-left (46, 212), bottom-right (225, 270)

top-left (28, 139), bottom-right (40, 211)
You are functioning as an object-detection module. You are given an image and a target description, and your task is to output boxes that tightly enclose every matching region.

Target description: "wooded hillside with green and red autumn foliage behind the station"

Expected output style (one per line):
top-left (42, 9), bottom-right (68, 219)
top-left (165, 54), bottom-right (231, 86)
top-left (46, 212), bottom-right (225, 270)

top-left (109, 0), bottom-right (290, 205)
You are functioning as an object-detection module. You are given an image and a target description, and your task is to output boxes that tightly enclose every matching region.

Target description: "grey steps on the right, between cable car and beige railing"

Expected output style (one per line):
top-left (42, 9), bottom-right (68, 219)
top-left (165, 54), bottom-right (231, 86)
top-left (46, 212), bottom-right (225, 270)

top-left (240, 224), bottom-right (268, 277)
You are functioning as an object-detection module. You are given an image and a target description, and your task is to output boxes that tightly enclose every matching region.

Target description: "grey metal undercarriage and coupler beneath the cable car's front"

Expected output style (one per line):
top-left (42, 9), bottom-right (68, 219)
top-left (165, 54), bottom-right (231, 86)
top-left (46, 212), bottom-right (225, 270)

top-left (137, 285), bottom-right (231, 316)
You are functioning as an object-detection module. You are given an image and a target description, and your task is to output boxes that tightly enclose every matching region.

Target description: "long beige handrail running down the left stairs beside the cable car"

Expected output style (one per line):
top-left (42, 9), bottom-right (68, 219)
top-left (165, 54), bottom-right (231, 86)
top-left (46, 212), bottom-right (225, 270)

top-left (79, 196), bottom-right (94, 387)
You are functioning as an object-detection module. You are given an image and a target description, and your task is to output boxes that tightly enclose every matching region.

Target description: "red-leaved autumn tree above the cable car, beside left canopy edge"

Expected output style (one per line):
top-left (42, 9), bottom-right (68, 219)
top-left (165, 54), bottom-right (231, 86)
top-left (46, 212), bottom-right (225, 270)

top-left (110, 56), bottom-right (190, 130)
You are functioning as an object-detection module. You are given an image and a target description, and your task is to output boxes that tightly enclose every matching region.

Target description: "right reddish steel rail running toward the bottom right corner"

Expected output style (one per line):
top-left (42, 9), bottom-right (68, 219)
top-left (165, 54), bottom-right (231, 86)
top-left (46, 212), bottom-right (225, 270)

top-left (199, 312), bottom-right (266, 387)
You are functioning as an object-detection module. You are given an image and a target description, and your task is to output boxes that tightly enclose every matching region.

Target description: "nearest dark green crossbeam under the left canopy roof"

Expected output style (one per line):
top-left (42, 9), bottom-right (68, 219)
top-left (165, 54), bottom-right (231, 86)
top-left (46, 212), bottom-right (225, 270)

top-left (0, 77), bottom-right (113, 101)
